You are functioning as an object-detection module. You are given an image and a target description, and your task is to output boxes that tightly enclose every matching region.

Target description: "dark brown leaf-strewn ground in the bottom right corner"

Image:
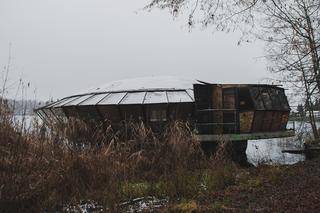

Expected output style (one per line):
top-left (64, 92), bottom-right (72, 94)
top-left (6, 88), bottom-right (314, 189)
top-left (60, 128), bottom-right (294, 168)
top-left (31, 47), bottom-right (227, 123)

top-left (167, 158), bottom-right (320, 212)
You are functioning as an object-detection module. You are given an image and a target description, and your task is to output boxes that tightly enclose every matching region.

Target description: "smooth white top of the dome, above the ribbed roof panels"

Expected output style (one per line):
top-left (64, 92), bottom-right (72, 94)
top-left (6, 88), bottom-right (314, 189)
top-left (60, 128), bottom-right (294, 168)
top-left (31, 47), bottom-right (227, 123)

top-left (79, 76), bottom-right (199, 94)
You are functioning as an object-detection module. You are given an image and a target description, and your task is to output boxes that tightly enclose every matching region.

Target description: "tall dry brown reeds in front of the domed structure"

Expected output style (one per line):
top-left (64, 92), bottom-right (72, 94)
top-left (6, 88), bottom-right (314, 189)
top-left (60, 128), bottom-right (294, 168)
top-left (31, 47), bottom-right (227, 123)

top-left (0, 100), bottom-right (240, 212)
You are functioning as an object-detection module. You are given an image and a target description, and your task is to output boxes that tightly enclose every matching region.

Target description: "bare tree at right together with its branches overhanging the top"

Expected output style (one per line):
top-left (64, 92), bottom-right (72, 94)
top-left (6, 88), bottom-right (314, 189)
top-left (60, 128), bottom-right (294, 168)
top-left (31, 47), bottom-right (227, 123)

top-left (148, 0), bottom-right (320, 139)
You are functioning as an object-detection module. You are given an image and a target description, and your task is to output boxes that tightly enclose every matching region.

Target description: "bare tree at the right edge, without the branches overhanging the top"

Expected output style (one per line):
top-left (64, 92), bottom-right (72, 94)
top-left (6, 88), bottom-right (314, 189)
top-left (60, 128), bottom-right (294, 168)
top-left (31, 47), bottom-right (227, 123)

top-left (257, 0), bottom-right (320, 139)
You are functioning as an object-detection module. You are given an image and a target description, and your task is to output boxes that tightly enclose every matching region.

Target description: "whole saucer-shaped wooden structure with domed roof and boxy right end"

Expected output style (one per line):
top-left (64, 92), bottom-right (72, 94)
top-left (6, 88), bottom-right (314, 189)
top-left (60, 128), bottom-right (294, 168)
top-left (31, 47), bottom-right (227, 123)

top-left (36, 77), bottom-right (294, 163)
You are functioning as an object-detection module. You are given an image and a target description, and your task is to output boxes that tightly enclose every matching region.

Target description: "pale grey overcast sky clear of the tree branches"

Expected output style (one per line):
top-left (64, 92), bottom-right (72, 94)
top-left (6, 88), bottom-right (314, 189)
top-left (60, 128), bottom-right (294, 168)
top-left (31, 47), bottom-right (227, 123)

top-left (0, 0), bottom-right (269, 100)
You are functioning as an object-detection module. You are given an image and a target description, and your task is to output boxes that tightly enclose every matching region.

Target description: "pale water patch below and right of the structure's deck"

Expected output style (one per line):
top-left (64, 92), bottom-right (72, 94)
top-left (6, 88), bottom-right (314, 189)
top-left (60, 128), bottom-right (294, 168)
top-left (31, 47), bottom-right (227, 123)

top-left (246, 121), bottom-right (320, 165)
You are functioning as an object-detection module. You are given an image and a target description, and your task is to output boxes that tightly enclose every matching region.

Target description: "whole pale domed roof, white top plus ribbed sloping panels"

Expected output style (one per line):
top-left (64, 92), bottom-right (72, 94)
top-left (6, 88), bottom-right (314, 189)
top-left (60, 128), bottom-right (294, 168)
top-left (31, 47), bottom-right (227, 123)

top-left (44, 76), bottom-right (200, 108)
